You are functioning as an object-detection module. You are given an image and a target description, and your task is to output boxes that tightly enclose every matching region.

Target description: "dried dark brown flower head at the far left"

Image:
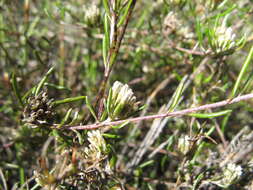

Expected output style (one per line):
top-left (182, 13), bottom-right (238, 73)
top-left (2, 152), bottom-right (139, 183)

top-left (23, 91), bottom-right (55, 127)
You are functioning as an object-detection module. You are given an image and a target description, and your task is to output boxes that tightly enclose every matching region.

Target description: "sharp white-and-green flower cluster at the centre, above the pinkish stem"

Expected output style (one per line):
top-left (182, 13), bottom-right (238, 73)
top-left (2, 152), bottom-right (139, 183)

top-left (108, 81), bottom-right (137, 120)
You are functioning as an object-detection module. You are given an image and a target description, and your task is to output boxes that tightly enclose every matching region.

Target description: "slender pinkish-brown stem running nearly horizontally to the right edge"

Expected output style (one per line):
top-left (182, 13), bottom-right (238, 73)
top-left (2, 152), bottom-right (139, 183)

top-left (68, 93), bottom-right (253, 130)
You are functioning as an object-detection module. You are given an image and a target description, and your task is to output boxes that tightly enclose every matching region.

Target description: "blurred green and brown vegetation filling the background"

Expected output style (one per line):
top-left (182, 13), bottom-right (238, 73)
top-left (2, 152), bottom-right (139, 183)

top-left (0, 0), bottom-right (253, 190)
